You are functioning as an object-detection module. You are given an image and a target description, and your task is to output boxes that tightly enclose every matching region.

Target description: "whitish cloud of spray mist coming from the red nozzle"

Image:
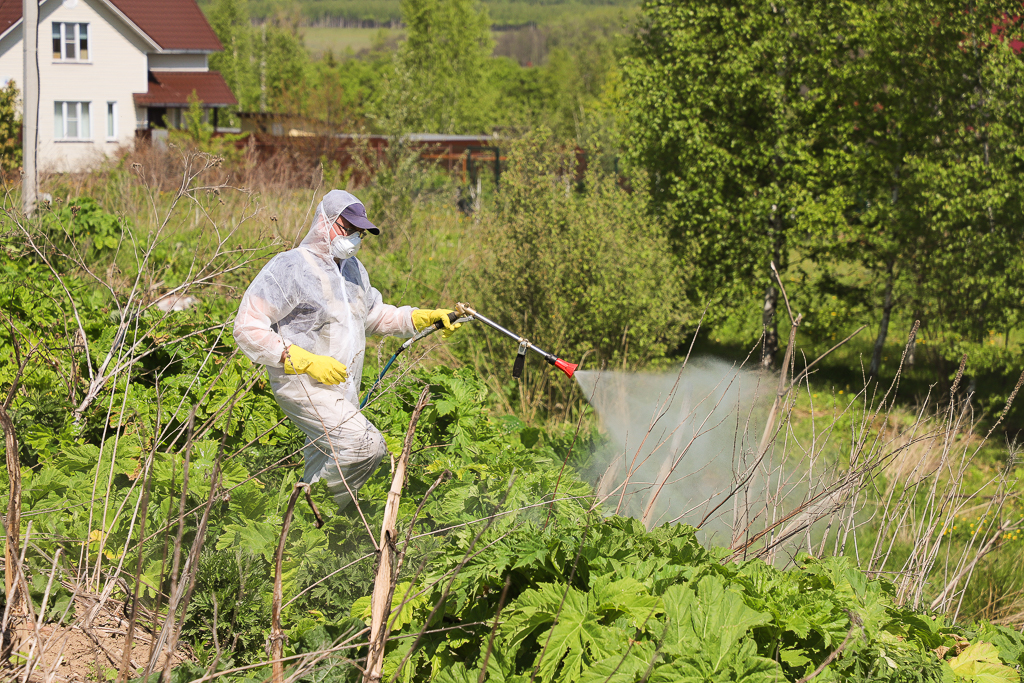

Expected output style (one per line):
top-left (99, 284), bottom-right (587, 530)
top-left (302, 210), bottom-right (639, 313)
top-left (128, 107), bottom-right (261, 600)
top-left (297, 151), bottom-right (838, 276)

top-left (575, 357), bottom-right (776, 544)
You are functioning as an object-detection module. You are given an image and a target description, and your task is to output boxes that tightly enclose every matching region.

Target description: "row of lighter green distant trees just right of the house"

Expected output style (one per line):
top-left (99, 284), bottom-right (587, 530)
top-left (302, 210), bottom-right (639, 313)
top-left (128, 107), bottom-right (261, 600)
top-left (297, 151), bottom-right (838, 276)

top-left (207, 0), bottom-right (623, 143)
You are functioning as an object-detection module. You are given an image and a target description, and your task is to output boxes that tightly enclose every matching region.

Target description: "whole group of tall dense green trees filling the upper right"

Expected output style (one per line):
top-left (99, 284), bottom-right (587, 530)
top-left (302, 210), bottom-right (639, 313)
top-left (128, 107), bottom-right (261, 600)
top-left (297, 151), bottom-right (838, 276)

top-left (621, 0), bottom-right (1024, 387)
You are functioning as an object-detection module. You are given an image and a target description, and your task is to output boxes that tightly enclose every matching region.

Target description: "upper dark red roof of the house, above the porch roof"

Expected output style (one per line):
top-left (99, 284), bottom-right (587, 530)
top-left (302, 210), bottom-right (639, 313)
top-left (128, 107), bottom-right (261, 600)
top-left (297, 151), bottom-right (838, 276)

top-left (0, 0), bottom-right (223, 52)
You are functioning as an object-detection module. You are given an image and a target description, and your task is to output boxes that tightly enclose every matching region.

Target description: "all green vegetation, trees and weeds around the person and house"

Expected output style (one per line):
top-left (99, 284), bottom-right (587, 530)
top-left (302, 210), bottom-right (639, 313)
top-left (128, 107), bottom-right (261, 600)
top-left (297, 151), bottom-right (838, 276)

top-left (0, 0), bottom-right (1024, 681)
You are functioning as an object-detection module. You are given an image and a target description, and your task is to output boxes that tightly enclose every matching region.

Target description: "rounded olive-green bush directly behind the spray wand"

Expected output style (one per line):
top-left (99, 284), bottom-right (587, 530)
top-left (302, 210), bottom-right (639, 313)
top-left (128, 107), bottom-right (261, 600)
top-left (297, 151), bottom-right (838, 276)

top-left (478, 130), bottom-right (691, 389)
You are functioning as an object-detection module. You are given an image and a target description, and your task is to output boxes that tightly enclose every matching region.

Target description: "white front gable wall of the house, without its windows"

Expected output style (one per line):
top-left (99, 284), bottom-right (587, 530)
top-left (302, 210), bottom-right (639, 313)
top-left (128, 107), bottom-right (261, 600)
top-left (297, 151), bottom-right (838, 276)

top-left (0, 0), bottom-right (152, 172)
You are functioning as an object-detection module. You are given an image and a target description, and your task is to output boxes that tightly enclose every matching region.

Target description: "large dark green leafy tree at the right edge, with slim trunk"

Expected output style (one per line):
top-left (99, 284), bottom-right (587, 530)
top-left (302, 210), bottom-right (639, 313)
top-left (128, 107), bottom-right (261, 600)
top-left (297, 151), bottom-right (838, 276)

top-left (823, 2), bottom-right (1024, 375)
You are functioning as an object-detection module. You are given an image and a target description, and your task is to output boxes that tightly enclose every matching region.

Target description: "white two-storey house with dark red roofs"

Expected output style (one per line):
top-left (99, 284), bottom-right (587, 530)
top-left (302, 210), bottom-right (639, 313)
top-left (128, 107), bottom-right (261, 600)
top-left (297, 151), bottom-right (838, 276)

top-left (0, 0), bottom-right (238, 172)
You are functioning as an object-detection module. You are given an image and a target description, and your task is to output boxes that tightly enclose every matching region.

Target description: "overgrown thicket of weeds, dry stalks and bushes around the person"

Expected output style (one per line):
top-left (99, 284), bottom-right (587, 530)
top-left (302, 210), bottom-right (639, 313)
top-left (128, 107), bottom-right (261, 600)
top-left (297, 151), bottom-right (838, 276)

top-left (0, 141), bottom-right (1024, 681)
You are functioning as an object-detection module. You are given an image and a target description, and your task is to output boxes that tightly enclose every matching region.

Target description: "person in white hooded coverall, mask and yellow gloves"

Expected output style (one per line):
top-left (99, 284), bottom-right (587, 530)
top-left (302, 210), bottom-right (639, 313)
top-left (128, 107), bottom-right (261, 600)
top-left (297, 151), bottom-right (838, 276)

top-left (234, 189), bottom-right (458, 508)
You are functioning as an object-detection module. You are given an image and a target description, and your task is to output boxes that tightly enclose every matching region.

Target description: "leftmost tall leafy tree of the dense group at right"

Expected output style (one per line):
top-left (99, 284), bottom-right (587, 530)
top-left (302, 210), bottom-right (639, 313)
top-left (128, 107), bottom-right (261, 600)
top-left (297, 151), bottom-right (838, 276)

top-left (622, 0), bottom-right (851, 364)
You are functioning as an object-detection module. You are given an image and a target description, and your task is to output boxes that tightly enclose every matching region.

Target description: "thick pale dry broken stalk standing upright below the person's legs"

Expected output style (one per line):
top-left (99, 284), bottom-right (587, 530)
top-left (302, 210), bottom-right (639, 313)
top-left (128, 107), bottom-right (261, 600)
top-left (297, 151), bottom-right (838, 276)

top-left (362, 385), bottom-right (430, 683)
